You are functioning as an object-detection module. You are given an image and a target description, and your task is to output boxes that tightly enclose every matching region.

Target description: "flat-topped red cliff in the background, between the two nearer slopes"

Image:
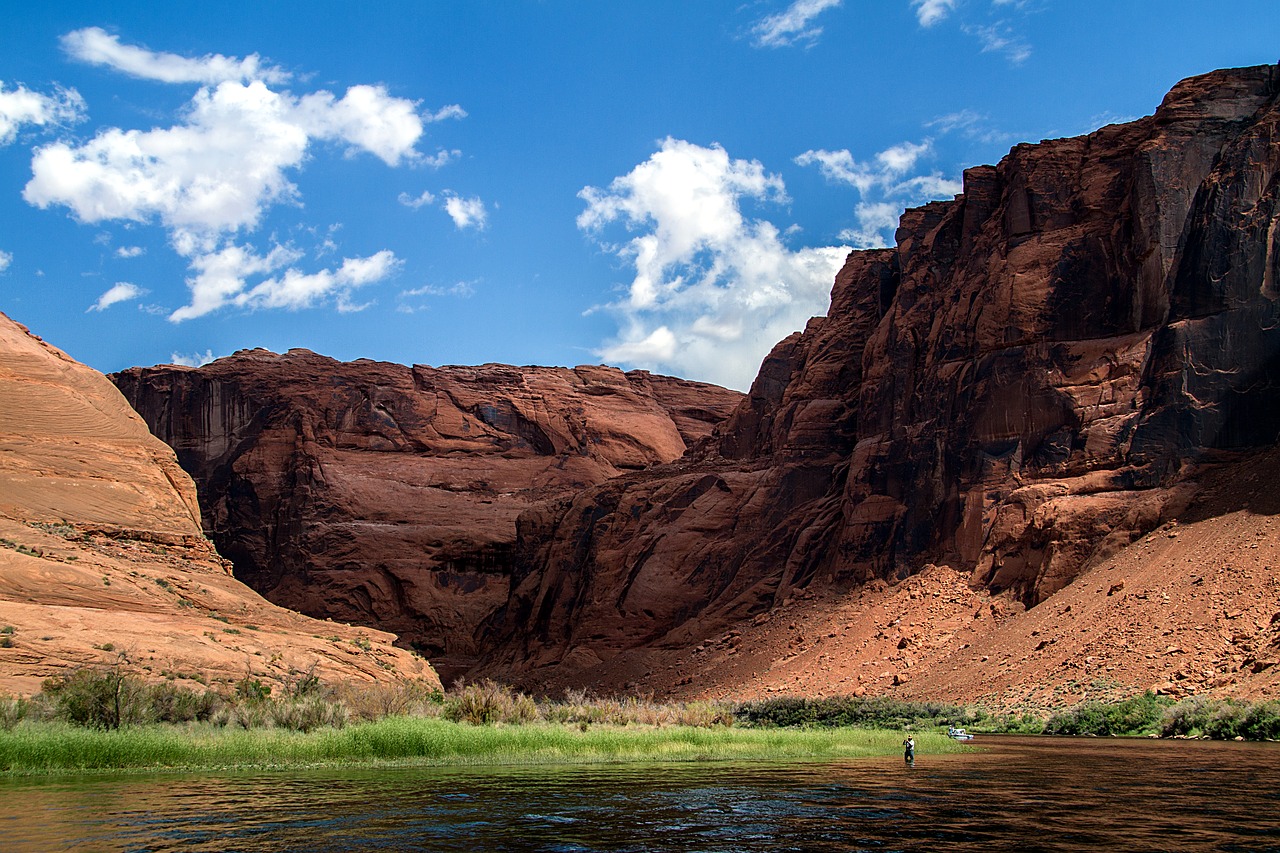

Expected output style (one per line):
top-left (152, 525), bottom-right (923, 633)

top-left (113, 350), bottom-right (741, 679)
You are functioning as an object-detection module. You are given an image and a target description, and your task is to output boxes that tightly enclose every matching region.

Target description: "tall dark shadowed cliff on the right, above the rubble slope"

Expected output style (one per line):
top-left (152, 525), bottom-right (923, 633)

top-left (480, 67), bottom-right (1280, 686)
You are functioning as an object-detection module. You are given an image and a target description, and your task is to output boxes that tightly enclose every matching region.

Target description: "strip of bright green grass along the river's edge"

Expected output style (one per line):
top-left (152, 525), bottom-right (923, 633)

top-left (0, 717), bottom-right (964, 776)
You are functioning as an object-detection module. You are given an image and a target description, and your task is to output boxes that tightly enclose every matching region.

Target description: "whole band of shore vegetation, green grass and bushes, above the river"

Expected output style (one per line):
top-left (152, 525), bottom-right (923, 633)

top-left (0, 669), bottom-right (1280, 775)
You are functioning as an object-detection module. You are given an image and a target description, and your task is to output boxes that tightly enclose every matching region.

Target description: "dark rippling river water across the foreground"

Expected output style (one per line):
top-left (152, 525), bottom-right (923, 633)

top-left (0, 736), bottom-right (1280, 853)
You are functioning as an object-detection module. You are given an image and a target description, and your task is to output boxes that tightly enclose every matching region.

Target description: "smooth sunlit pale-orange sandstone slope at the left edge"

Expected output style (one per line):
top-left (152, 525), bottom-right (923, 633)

top-left (0, 314), bottom-right (438, 693)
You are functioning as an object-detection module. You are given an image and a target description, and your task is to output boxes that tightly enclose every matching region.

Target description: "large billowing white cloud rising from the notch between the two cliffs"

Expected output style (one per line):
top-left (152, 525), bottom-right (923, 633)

top-left (577, 138), bottom-right (847, 388)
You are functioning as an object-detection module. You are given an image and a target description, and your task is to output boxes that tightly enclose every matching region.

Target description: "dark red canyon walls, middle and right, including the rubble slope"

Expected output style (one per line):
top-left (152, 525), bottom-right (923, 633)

top-left (97, 65), bottom-right (1280, 704)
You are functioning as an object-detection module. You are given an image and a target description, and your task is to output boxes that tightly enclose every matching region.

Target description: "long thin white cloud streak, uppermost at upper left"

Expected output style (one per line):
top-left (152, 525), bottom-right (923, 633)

top-left (61, 27), bottom-right (291, 83)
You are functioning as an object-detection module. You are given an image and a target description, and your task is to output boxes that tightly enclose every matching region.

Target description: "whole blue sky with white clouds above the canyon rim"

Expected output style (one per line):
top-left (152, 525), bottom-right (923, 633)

top-left (0, 0), bottom-right (1280, 389)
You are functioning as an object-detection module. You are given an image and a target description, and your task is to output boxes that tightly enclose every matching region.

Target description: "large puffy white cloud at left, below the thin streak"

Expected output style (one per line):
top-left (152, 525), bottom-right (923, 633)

top-left (23, 81), bottom-right (422, 236)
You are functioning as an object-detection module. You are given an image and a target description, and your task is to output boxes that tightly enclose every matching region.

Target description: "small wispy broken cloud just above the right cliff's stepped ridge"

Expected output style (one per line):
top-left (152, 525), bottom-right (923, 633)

top-left (795, 140), bottom-right (964, 248)
